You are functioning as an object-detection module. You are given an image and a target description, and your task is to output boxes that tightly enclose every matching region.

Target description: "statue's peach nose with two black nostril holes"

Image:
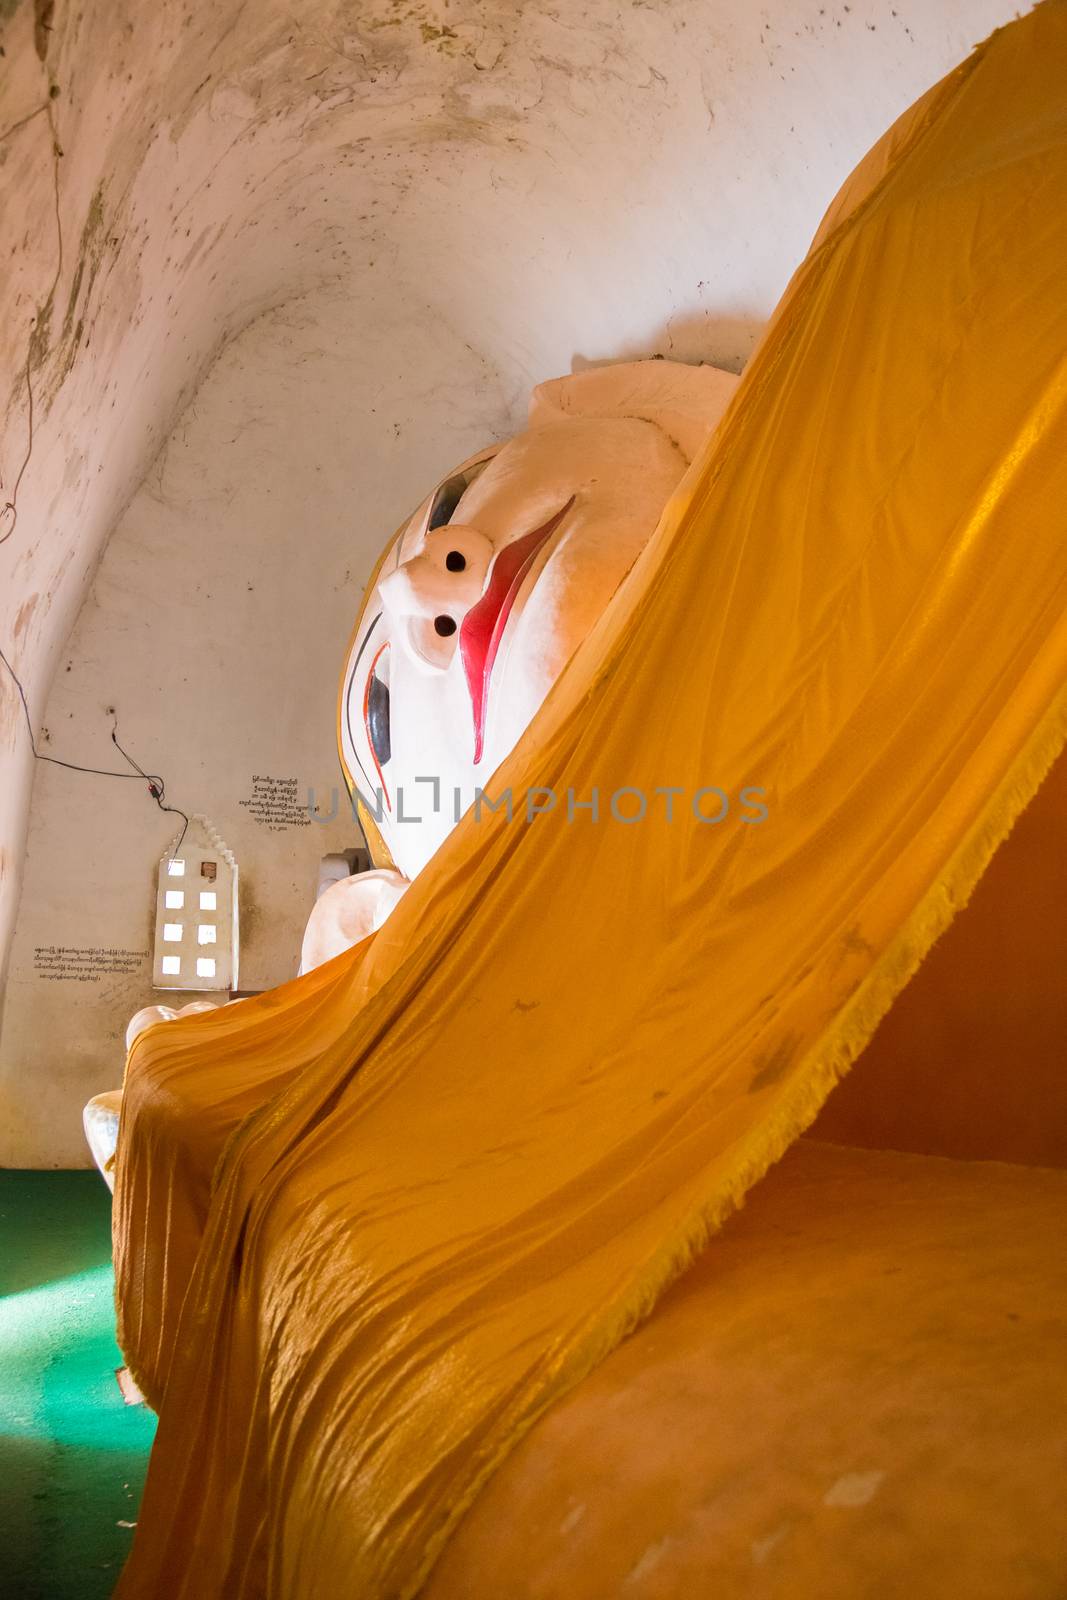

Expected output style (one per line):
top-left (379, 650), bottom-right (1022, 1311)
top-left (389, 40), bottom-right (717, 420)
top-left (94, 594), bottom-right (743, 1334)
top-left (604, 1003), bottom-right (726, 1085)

top-left (378, 523), bottom-right (493, 669)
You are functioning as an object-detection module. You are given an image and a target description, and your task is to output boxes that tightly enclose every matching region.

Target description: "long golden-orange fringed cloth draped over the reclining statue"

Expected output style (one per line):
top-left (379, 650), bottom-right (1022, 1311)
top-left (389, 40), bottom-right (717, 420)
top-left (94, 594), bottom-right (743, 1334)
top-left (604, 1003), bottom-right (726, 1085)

top-left (117, 0), bottom-right (1067, 1600)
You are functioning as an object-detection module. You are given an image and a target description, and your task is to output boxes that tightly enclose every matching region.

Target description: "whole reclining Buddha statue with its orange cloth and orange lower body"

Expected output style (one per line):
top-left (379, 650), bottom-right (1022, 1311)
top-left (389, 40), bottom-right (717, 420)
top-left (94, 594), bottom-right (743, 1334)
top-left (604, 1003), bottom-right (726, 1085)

top-left (97, 18), bottom-right (1067, 1600)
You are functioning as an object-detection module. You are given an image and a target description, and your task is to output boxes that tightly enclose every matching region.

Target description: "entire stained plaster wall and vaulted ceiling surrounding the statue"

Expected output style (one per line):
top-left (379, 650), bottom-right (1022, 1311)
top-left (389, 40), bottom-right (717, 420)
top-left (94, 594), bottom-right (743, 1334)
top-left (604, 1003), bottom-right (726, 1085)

top-left (0, 0), bottom-right (1013, 1165)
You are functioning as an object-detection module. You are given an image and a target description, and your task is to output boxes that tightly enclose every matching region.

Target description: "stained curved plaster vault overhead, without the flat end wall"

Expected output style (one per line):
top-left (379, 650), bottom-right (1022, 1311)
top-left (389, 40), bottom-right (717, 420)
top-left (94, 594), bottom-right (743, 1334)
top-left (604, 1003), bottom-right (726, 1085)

top-left (0, 0), bottom-right (1014, 1158)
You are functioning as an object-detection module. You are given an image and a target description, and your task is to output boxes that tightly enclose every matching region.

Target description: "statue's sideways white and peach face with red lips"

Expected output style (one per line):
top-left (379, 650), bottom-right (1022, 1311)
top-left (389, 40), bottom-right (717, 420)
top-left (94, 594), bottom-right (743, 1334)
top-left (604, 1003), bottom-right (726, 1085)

top-left (339, 362), bottom-right (736, 878)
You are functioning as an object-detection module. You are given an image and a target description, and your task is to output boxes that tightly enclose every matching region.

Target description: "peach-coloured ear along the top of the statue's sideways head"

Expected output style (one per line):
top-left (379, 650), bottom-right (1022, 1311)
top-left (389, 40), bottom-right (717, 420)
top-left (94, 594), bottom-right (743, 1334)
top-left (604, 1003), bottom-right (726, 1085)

top-left (530, 360), bottom-right (741, 461)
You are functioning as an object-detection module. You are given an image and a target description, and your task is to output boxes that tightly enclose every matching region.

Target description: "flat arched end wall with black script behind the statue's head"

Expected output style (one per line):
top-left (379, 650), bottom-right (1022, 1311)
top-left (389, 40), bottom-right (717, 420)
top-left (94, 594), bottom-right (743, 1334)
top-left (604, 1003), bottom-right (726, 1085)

top-left (2, 294), bottom-right (518, 1165)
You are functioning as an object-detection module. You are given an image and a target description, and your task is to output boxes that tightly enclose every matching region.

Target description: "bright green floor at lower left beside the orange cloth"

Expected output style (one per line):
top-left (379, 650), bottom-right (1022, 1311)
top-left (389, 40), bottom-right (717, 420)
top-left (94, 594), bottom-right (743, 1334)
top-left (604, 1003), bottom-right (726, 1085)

top-left (0, 1171), bottom-right (155, 1600)
